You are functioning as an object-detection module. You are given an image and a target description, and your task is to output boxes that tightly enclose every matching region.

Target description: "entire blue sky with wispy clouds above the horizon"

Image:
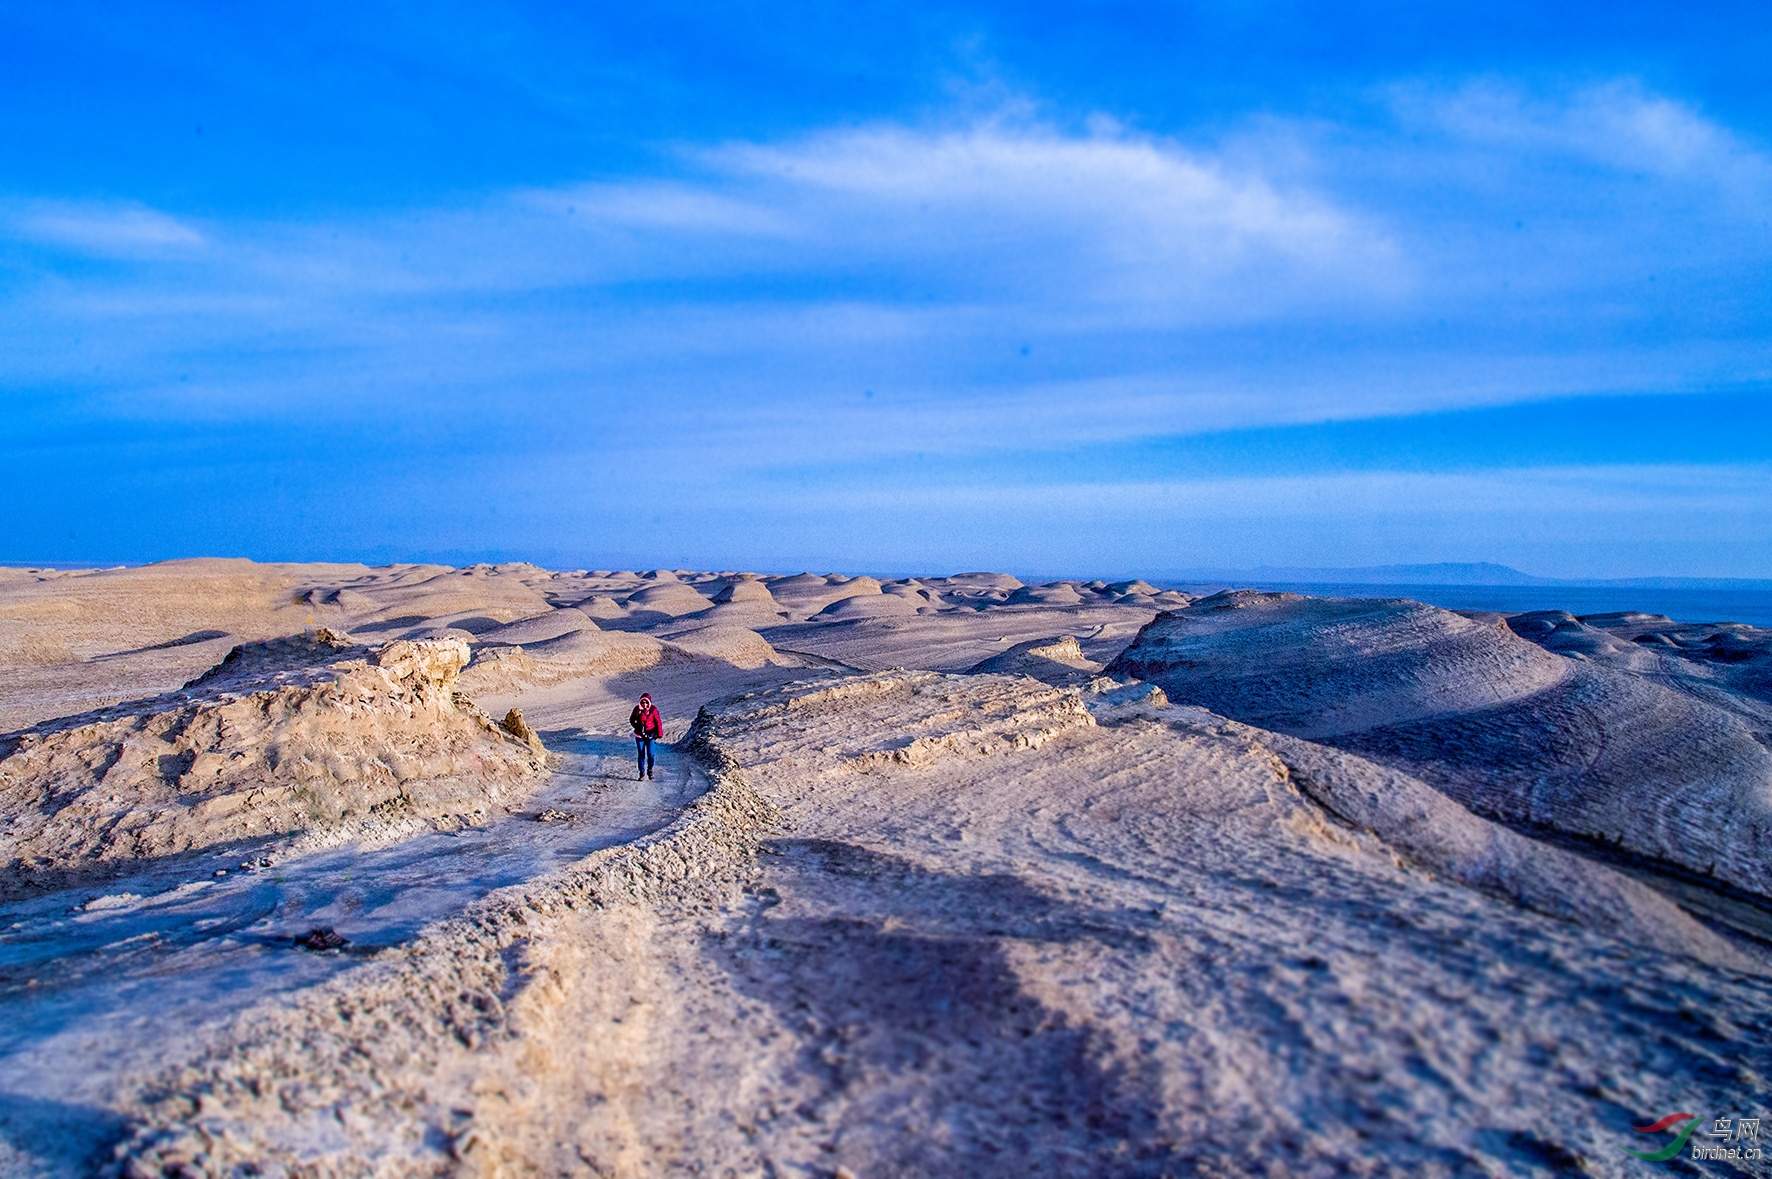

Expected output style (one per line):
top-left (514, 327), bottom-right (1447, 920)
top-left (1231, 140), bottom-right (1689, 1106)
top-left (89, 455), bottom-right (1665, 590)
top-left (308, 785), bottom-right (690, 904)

top-left (0, 4), bottom-right (1772, 576)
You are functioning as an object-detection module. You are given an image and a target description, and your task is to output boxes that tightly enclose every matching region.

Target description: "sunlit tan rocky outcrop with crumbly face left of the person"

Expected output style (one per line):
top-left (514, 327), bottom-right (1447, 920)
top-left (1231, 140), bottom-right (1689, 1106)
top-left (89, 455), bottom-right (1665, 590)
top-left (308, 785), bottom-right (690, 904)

top-left (0, 631), bottom-right (540, 895)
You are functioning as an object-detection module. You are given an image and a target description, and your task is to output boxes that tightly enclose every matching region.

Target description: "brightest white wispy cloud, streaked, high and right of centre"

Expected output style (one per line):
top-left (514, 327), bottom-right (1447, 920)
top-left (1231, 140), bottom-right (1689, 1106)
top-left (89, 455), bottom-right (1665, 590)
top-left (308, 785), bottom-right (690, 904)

top-left (705, 121), bottom-right (1407, 321)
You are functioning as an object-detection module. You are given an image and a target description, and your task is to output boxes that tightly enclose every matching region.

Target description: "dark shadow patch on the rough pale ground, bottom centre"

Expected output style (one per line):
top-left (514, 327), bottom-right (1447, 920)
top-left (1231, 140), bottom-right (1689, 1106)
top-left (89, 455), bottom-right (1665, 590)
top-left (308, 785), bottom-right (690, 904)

top-left (709, 839), bottom-right (1159, 1174)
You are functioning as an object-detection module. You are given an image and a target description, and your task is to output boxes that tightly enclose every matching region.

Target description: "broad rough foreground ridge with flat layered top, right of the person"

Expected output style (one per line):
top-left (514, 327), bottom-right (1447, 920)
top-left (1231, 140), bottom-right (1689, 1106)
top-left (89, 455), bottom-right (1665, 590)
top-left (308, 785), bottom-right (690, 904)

top-left (117, 672), bottom-right (1772, 1177)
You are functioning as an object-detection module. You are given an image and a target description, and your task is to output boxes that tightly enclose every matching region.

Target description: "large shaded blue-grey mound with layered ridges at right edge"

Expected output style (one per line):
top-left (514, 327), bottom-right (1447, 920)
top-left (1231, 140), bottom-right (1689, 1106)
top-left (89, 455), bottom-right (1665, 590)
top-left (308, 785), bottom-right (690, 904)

top-left (1108, 594), bottom-right (1772, 897)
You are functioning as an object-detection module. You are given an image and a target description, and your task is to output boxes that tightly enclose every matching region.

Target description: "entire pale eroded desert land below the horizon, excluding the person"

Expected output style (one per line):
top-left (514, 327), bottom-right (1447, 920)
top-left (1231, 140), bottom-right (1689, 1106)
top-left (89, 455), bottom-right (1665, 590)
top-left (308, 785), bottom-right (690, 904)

top-left (0, 560), bottom-right (1772, 1179)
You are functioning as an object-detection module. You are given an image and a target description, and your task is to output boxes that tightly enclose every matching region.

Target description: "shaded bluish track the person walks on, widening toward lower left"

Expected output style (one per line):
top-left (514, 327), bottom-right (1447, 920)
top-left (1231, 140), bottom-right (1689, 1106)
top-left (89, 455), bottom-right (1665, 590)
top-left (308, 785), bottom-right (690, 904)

top-left (0, 729), bottom-right (707, 1170)
